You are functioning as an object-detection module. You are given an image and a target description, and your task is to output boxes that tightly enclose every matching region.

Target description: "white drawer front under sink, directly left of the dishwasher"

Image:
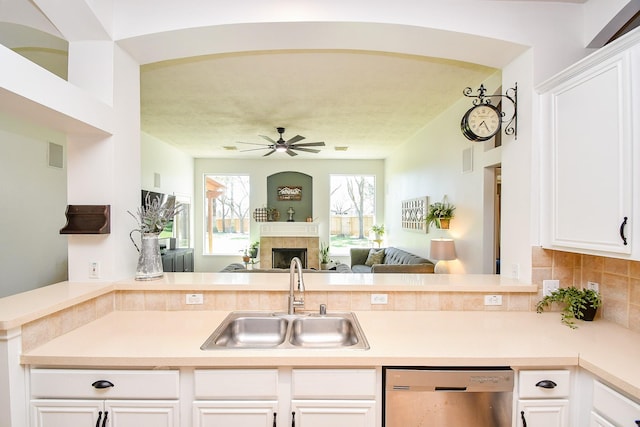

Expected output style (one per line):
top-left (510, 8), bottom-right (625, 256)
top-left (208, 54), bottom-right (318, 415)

top-left (291, 369), bottom-right (376, 399)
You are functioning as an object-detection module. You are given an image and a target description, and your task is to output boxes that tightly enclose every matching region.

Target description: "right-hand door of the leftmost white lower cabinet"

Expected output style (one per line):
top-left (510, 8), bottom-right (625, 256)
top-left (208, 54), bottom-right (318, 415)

top-left (104, 400), bottom-right (180, 427)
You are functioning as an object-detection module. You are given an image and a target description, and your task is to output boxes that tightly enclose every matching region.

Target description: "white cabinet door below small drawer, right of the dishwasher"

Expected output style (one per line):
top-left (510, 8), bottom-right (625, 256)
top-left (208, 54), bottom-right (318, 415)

top-left (516, 399), bottom-right (569, 427)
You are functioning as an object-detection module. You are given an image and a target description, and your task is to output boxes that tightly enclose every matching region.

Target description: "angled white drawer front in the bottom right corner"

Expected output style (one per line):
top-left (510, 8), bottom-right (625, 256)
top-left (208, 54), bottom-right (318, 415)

top-left (593, 381), bottom-right (640, 426)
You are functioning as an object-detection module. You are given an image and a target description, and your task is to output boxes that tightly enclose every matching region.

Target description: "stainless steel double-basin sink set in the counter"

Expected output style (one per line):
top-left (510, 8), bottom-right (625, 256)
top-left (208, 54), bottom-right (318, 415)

top-left (200, 311), bottom-right (369, 350)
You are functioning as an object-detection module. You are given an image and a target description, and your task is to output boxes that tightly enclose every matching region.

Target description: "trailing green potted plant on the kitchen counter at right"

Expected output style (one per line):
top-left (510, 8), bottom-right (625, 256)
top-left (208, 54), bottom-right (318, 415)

top-left (536, 286), bottom-right (602, 329)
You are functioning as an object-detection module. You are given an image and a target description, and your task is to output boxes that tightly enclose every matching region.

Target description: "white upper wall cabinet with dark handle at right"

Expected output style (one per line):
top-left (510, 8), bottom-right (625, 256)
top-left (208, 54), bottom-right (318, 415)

top-left (539, 33), bottom-right (640, 257)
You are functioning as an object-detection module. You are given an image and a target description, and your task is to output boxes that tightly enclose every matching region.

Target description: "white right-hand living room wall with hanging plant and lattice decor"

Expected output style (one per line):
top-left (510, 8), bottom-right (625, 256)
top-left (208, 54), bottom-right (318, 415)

top-left (385, 73), bottom-right (501, 273)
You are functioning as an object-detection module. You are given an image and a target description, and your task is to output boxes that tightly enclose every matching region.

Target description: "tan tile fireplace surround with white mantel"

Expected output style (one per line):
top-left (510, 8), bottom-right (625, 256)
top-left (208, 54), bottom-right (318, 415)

top-left (260, 222), bottom-right (320, 270)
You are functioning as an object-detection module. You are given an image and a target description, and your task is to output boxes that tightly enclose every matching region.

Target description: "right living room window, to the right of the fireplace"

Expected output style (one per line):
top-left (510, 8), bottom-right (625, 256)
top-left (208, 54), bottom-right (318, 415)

top-left (329, 175), bottom-right (376, 255)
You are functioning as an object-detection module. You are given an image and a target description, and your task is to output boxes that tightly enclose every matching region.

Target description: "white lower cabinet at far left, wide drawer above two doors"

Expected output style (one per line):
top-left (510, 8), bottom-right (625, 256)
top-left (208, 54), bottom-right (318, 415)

top-left (30, 369), bottom-right (180, 427)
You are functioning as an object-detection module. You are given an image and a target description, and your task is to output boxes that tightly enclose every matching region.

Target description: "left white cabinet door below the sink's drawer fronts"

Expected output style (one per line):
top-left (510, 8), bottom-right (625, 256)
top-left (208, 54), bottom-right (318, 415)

top-left (193, 400), bottom-right (278, 427)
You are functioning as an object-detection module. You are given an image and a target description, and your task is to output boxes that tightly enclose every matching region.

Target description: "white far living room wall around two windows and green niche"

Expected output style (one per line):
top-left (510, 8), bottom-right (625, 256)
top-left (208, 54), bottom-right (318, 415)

top-left (194, 159), bottom-right (385, 271)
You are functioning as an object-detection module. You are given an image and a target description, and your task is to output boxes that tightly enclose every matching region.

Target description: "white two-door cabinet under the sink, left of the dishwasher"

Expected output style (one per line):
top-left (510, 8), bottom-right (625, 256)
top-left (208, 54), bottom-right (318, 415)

top-left (193, 368), bottom-right (376, 427)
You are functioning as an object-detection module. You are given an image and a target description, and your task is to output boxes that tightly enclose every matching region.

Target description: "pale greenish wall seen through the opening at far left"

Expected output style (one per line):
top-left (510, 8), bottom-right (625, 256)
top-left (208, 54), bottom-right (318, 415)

top-left (0, 114), bottom-right (67, 297)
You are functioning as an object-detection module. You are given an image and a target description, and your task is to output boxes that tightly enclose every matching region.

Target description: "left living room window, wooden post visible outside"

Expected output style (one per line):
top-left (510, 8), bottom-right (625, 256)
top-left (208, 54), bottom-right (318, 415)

top-left (204, 175), bottom-right (250, 255)
